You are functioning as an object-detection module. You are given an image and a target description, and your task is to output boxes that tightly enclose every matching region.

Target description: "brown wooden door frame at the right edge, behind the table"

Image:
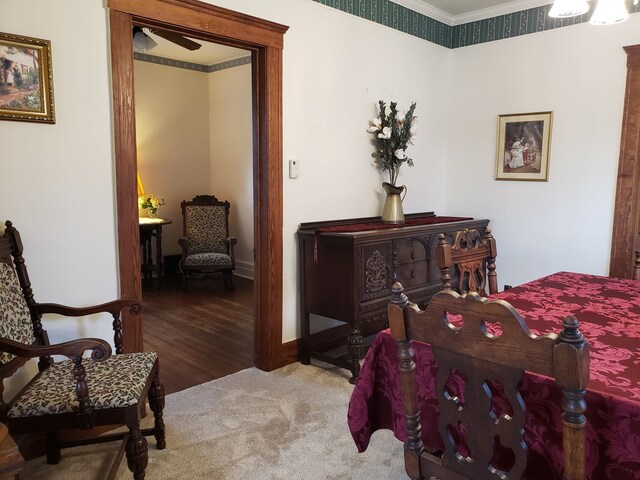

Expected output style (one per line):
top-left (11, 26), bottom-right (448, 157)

top-left (609, 45), bottom-right (640, 278)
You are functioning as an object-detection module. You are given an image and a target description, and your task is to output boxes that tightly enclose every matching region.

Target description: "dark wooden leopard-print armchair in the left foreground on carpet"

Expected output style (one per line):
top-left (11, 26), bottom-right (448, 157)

top-left (0, 221), bottom-right (165, 480)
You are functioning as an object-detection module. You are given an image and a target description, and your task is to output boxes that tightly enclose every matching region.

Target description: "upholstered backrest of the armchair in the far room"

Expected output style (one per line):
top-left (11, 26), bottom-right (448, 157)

top-left (180, 195), bottom-right (231, 255)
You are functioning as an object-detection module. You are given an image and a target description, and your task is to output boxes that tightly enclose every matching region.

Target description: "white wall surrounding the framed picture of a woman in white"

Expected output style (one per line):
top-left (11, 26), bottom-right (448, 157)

top-left (446, 15), bottom-right (640, 288)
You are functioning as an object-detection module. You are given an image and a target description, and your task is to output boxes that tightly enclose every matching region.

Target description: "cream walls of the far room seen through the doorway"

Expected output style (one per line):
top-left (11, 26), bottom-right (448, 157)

top-left (134, 60), bottom-right (253, 278)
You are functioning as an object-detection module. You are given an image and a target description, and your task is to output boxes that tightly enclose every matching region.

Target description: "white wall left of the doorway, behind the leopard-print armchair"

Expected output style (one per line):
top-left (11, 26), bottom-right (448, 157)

top-left (0, 0), bottom-right (119, 396)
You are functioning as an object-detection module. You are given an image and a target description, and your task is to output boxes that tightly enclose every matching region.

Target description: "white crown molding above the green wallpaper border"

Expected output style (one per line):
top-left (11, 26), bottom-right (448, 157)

top-left (393, 0), bottom-right (553, 26)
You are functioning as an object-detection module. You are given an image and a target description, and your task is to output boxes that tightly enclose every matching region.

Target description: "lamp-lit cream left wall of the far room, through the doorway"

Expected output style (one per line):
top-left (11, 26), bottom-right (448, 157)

top-left (134, 61), bottom-right (211, 255)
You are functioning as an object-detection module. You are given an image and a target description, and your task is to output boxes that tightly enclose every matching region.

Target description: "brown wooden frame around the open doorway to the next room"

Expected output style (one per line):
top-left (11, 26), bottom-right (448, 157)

top-left (107, 0), bottom-right (288, 370)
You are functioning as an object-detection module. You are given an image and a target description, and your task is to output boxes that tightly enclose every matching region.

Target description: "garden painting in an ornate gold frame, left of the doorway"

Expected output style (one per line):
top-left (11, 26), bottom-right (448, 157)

top-left (0, 32), bottom-right (55, 123)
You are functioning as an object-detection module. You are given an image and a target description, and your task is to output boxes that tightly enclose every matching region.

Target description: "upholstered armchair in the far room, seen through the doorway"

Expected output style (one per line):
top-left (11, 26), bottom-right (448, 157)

top-left (178, 195), bottom-right (237, 289)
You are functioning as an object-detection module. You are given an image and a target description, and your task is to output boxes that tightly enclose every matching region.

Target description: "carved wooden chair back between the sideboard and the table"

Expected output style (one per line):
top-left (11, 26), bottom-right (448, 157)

top-left (436, 227), bottom-right (498, 297)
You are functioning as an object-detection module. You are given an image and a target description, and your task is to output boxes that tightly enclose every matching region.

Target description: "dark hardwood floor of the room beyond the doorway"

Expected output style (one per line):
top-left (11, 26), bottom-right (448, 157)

top-left (142, 276), bottom-right (254, 394)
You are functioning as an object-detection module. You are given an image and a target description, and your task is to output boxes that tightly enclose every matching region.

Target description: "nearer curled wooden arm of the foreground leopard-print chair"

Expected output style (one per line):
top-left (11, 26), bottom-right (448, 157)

top-left (0, 337), bottom-right (111, 362)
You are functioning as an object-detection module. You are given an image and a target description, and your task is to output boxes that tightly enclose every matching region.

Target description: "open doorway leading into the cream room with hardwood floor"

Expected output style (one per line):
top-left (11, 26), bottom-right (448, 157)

top-left (134, 34), bottom-right (254, 393)
